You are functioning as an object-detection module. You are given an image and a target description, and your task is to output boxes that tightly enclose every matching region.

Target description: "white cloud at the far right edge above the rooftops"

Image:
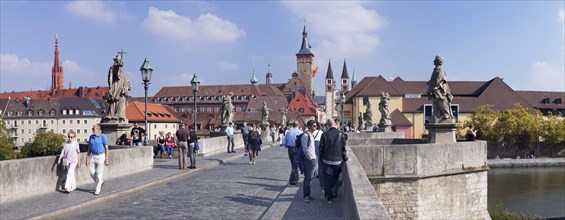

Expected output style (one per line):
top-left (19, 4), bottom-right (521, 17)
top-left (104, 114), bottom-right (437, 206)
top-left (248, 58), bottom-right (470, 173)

top-left (526, 61), bottom-right (565, 91)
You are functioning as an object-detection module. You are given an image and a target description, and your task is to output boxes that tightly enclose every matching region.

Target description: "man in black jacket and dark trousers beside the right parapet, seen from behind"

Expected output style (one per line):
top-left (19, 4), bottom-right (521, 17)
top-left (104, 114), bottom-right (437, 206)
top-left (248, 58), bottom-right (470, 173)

top-left (320, 119), bottom-right (347, 203)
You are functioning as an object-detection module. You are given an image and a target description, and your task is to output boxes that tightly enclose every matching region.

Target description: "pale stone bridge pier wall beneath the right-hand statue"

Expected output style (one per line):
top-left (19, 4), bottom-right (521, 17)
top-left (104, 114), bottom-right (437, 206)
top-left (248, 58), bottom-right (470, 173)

top-left (348, 133), bottom-right (490, 219)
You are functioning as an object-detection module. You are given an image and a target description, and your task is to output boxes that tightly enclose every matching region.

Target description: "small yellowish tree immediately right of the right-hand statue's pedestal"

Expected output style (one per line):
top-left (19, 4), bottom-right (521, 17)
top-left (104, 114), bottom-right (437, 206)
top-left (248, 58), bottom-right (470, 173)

top-left (465, 104), bottom-right (501, 142)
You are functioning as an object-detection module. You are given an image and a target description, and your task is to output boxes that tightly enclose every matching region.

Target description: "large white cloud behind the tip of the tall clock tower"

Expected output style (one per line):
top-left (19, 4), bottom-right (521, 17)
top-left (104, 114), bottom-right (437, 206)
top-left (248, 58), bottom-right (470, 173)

top-left (283, 1), bottom-right (384, 58)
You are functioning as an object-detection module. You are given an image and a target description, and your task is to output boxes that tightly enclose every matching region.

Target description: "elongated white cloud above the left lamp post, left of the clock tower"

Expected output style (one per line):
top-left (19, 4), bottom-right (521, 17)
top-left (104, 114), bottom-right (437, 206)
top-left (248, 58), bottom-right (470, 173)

top-left (142, 7), bottom-right (246, 46)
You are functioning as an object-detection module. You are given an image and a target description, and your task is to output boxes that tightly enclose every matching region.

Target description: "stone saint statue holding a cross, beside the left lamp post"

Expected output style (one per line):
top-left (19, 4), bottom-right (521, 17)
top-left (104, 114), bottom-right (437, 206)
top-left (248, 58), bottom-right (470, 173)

top-left (104, 54), bottom-right (131, 123)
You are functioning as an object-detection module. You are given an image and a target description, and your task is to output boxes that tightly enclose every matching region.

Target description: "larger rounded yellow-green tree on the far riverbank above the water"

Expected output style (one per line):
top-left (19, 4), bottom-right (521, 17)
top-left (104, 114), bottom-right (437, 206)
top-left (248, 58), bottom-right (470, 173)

top-left (494, 103), bottom-right (543, 148)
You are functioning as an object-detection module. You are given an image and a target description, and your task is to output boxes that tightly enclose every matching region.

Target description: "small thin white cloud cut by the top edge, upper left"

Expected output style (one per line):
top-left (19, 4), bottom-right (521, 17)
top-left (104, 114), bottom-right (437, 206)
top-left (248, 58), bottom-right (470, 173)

top-left (65, 1), bottom-right (128, 24)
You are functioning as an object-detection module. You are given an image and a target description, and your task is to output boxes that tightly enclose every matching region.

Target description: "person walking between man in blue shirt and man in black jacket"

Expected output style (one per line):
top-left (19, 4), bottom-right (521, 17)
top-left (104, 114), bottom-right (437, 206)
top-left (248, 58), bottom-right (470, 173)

top-left (297, 120), bottom-right (318, 203)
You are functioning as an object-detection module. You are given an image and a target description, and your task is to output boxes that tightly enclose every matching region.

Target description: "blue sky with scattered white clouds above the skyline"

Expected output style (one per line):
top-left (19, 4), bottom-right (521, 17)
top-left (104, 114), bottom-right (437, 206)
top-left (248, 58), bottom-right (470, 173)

top-left (0, 0), bottom-right (565, 96)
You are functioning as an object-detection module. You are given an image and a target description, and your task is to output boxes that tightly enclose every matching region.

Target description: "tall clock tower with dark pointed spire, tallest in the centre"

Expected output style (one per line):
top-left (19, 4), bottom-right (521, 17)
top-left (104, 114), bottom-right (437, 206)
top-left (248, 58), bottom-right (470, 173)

top-left (296, 25), bottom-right (314, 94)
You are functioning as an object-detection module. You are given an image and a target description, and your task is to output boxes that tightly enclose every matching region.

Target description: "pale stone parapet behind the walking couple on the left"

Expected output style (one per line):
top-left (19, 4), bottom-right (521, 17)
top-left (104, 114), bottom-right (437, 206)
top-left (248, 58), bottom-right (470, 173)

top-left (0, 146), bottom-right (153, 203)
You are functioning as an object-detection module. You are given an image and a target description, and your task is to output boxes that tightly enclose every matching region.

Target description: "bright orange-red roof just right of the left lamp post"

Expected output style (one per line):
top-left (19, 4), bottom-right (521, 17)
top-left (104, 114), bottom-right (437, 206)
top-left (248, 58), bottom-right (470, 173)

top-left (126, 102), bottom-right (180, 122)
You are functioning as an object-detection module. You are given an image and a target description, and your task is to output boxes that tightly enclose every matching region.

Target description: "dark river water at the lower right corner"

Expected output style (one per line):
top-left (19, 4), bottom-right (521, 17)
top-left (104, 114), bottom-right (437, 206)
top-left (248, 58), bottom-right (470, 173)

top-left (488, 167), bottom-right (565, 218)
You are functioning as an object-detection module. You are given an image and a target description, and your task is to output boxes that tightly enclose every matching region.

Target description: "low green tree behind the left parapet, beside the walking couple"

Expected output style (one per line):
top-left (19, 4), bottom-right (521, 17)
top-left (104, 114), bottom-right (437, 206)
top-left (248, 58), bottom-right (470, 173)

top-left (22, 131), bottom-right (65, 157)
